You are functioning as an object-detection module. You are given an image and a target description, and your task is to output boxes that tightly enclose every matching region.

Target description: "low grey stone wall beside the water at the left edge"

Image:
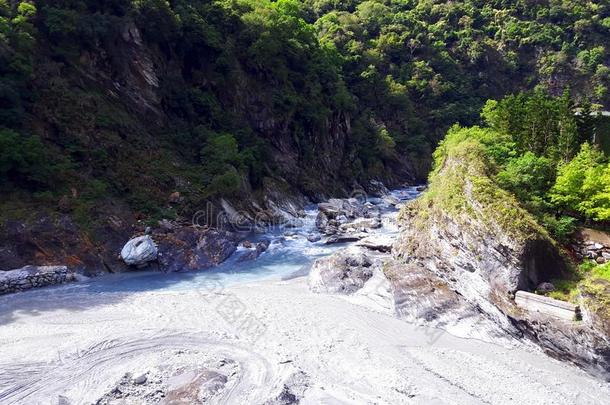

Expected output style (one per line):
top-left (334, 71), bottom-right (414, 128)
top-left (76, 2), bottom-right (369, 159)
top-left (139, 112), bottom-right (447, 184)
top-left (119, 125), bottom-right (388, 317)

top-left (0, 266), bottom-right (75, 294)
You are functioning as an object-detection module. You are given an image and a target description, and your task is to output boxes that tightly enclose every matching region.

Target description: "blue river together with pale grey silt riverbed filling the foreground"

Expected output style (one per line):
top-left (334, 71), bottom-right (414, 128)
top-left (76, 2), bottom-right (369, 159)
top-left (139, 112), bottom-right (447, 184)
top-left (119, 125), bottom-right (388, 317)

top-left (0, 188), bottom-right (610, 405)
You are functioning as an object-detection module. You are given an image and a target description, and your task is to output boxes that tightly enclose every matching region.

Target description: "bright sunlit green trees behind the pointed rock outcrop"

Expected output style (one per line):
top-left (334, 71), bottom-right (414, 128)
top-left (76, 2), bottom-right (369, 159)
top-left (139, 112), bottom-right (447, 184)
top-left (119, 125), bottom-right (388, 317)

top-left (435, 90), bottom-right (610, 245)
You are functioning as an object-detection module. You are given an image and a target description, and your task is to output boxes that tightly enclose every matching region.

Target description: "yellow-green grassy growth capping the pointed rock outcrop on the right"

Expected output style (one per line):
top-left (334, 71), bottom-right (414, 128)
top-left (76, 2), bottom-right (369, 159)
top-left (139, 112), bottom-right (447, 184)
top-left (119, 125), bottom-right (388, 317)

top-left (408, 125), bottom-right (547, 242)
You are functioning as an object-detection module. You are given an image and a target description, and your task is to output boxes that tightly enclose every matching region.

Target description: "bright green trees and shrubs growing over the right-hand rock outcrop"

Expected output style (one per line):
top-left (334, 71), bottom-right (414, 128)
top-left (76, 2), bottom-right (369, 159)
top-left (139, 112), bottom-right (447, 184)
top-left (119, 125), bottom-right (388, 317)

top-left (418, 90), bottom-right (610, 312)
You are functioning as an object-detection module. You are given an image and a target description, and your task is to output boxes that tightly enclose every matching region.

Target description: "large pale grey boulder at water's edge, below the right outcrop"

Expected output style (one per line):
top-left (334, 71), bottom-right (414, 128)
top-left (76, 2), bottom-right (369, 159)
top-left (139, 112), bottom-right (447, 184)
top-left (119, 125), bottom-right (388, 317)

top-left (309, 249), bottom-right (373, 294)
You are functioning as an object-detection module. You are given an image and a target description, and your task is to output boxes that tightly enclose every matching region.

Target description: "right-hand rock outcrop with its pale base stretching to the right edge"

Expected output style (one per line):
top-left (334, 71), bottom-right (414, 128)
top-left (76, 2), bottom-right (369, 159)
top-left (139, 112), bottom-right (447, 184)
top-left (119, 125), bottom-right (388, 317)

top-left (391, 137), bottom-right (610, 378)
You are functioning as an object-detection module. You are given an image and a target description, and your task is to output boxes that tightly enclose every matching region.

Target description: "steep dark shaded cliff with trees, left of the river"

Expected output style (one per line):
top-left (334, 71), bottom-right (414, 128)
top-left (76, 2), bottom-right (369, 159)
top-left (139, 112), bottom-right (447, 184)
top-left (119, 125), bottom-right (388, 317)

top-left (0, 0), bottom-right (420, 272)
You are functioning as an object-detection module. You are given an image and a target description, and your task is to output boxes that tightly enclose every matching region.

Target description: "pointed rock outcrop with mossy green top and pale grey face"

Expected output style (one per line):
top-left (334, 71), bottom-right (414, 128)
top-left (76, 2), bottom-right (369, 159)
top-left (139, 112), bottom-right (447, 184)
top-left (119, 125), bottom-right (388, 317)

top-left (396, 129), bottom-right (567, 311)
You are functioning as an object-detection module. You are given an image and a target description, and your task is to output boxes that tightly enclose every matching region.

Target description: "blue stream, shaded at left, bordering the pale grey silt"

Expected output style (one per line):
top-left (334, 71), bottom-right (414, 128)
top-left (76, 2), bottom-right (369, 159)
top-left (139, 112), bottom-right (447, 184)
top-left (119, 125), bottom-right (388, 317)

top-left (0, 187), bottom-right (419, 326)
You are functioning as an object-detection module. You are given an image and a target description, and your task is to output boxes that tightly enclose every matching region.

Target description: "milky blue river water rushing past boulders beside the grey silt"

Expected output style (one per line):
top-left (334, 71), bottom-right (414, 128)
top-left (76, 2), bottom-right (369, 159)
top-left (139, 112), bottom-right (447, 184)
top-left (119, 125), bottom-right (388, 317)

top-left (0, 187), bottom-right (419, 300)
